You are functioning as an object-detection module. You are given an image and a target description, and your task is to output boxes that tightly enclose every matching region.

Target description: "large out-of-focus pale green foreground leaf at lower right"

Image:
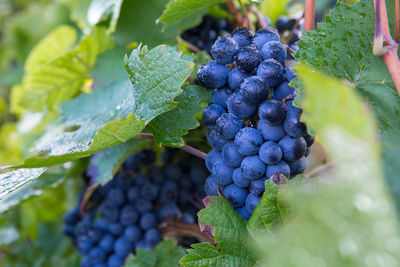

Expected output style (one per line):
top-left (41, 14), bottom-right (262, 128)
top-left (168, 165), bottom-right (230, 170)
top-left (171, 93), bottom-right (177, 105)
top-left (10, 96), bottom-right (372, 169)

top-left (260, 66), bottom-right (400, 267)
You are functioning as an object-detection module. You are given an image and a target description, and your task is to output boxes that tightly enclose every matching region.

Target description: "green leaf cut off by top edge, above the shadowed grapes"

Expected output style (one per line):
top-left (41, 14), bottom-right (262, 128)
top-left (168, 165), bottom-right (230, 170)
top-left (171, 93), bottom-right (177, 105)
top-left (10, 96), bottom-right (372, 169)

top-left (157, 0), bottom-right (225, 29)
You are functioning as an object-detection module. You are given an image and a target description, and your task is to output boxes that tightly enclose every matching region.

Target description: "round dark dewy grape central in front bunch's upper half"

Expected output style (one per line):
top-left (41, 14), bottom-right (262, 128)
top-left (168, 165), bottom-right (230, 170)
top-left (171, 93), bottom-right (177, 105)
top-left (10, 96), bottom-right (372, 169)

top-left (240, 76), bottom-right (269, 105)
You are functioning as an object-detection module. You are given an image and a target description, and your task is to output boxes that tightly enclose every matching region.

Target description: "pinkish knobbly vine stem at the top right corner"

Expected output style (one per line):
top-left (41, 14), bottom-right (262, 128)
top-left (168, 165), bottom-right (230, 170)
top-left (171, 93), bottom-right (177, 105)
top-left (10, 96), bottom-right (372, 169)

top-left (372, 0), bottom-right (400, 94)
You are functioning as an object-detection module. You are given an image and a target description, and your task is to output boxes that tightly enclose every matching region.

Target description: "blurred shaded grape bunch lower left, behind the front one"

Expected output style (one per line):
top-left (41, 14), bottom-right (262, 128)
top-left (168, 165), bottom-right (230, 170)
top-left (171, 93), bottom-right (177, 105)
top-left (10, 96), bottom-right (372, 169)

top-left (64, 150), bottom-right (207, 267)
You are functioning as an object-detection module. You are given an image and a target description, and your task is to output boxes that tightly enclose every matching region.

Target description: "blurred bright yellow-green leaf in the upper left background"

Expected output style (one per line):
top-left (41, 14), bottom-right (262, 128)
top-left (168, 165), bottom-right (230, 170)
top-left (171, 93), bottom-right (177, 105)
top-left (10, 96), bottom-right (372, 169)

top-left (11, 26), bottom-right (111, 113)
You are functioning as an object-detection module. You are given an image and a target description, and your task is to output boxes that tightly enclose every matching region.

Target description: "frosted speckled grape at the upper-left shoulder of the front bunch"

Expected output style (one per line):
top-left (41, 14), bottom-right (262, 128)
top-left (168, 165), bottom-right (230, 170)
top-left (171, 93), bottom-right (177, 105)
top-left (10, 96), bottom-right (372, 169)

top-left (211, 36), bottom-right (239, 64)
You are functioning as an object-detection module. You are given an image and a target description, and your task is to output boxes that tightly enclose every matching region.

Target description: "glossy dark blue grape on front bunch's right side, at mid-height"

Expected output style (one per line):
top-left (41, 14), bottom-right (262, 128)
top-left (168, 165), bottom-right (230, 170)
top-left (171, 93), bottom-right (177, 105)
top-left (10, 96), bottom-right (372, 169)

top-left (258, 99), bottom-right (286, 125)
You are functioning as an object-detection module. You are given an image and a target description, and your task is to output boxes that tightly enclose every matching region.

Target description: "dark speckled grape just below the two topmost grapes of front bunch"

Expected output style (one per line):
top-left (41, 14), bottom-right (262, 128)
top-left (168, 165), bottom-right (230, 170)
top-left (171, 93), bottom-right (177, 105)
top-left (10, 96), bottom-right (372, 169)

top-left (235, 45), bottom-right (262, 73)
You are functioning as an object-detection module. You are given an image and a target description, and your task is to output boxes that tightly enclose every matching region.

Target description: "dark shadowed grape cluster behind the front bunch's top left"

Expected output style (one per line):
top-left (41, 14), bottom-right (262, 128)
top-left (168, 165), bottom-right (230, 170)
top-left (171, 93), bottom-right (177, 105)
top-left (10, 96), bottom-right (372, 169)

top-left (182, 16), bottom-right (233, 54)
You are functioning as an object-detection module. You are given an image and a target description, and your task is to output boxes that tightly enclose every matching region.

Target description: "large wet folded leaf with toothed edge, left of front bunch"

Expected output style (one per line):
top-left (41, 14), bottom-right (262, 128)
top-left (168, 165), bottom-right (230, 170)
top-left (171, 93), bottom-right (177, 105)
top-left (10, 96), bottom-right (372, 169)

top-left (10, 45), bottom-right (193, 168)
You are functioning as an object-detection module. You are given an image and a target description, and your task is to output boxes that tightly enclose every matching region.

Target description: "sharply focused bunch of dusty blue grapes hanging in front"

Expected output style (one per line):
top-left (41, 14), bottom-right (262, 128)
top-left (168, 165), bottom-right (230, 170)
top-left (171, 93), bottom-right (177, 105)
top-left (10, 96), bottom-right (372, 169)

top-left (197, 28), bottom-right (314, 219)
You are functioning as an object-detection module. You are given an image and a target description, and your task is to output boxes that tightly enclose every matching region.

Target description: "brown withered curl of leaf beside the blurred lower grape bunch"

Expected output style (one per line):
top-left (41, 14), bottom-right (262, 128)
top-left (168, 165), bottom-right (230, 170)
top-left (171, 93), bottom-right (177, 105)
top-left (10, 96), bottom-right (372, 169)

top-left (158, 217), bottom-right (215, 244)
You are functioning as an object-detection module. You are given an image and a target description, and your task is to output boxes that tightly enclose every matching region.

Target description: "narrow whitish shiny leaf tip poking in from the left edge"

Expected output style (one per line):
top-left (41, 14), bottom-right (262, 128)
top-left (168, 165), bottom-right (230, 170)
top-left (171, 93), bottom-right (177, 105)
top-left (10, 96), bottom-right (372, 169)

top-left (0, 168), bottom-right (46, 200)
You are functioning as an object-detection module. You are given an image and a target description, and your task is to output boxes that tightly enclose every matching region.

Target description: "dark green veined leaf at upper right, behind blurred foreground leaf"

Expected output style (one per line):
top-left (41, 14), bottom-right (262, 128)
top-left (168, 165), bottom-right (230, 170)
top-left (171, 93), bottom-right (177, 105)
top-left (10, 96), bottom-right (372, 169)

top-left (297, 0), bottom-right (400, 209)
